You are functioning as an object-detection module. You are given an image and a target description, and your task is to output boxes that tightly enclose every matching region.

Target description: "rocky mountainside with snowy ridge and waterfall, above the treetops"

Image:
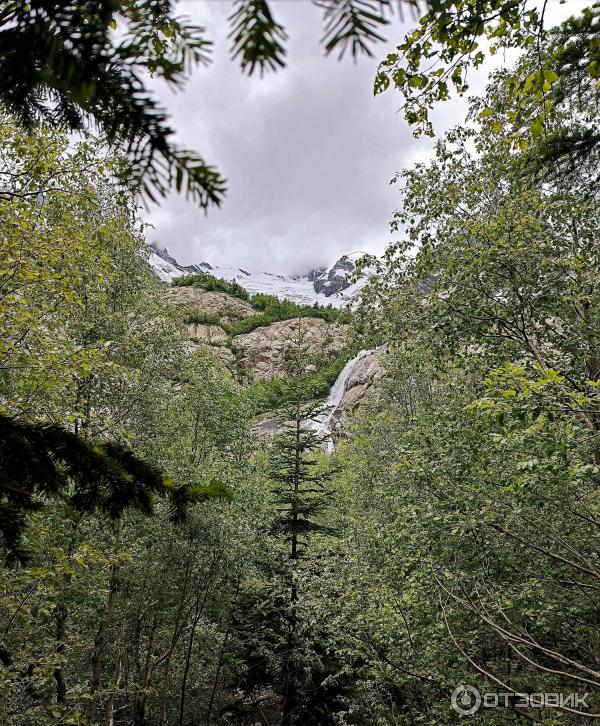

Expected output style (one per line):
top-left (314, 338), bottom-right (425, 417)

top-left (149, 248), bottom-right (382, 450)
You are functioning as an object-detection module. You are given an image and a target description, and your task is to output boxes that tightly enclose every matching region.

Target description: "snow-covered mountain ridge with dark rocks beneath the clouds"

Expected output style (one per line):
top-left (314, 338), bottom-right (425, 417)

top-left (148, 243), bottom-right (366, 307)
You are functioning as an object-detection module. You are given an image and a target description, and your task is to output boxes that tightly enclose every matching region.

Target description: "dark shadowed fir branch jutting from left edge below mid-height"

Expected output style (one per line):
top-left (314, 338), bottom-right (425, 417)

top-left (0, 415), bottom-right (229, 559)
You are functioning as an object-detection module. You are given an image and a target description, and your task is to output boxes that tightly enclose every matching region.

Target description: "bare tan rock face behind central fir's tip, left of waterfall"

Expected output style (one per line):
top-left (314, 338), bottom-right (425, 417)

top-left (233, 318), bottom-right (347, 380)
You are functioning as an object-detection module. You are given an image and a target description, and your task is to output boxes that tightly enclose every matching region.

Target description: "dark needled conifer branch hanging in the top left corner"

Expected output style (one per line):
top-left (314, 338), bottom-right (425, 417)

top-left (0, 0), bottom-right (225, 209)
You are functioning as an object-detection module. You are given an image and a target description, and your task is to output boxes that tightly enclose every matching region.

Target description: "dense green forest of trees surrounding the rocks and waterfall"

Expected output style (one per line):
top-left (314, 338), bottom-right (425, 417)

top-left (0, 1), bottom-right (600, 726)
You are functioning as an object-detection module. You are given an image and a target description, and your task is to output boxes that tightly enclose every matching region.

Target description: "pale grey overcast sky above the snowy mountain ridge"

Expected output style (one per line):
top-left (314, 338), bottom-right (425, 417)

top-left (147, 0), bottom-right (589, 273)
